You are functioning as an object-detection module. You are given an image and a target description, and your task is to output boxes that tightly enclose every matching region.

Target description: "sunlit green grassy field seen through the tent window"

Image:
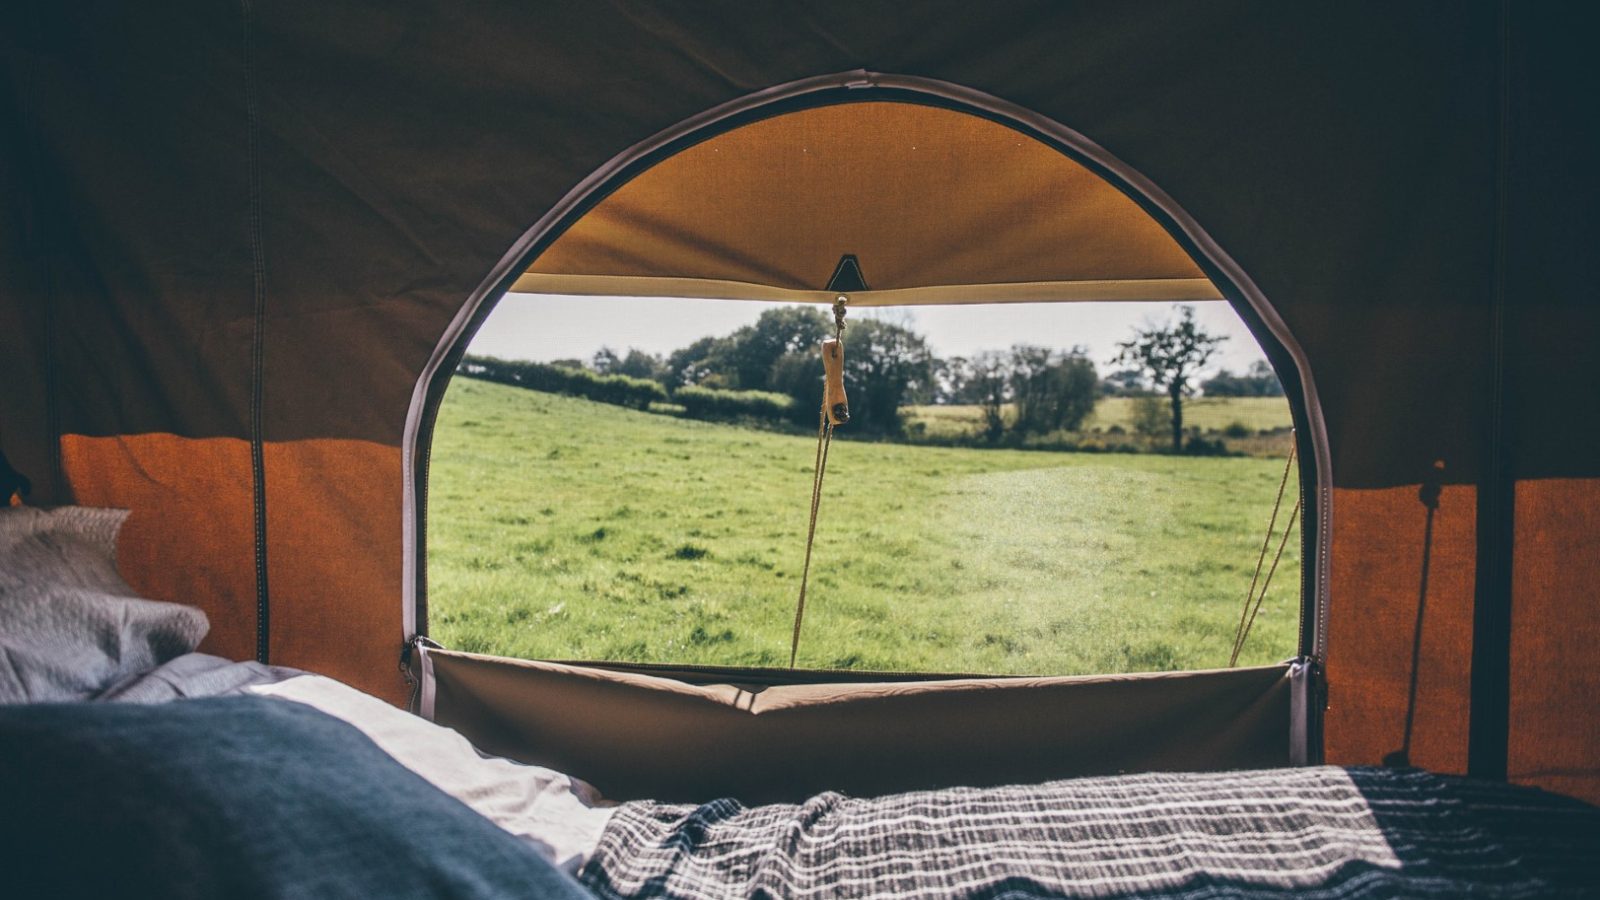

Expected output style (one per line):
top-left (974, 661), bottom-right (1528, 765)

top-left (427, 378), bottom-right (1299, 674)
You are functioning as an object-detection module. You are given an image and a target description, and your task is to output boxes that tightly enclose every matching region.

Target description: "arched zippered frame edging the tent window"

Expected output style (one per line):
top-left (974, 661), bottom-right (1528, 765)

top-left (402, 69), bottom-right (1333, 762)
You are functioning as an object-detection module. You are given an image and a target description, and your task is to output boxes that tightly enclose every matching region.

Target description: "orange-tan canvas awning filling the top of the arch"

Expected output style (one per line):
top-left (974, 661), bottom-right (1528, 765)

top-left (530, 101), bottom-right (1203, 290)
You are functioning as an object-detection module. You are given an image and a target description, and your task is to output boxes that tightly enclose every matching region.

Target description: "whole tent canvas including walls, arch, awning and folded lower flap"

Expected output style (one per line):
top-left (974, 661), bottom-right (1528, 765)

top-left (0, 2), bottom-right (1600, 890)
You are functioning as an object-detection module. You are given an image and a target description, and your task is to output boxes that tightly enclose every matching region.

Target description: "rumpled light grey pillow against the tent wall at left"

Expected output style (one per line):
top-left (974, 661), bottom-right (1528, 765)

top-left (0, 506), bottom-right (210, 703)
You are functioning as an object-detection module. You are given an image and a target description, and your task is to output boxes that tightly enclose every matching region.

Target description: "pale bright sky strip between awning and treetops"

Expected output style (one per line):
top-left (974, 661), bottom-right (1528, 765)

top-left (470, 293), bottom-right (1266, 373)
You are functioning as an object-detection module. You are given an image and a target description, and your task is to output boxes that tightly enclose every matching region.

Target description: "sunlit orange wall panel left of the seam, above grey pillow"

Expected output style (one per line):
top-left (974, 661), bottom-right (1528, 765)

top-left (61, 434), bottom-right (256, 660)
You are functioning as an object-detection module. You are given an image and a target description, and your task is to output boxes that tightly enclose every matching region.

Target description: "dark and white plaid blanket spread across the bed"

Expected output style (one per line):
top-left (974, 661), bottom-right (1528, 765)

top-left (581, 767), bottom-right (1600, 900)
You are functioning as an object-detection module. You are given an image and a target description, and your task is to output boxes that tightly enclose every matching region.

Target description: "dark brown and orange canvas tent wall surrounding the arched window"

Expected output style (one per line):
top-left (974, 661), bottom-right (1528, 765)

top-left (0, 2), bottom-right (1600, 798)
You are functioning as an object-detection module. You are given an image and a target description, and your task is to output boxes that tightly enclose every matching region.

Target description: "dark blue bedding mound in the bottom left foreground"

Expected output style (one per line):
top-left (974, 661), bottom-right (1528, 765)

top-left (0, 697), bottom-right (589, 900)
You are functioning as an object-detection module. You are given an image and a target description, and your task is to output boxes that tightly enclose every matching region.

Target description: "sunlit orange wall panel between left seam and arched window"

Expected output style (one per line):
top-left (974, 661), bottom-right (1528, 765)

top-left (264, 439), bottom-right (410, 705)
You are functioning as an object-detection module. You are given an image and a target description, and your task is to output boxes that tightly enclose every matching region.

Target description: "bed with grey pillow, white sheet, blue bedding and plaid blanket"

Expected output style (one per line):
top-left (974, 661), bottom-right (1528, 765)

top-left (0, 511), bottom-right (1600, 898)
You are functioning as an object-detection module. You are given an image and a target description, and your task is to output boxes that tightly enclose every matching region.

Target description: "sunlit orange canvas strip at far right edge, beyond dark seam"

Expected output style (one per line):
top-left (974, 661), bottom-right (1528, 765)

top-left (1507, 479), bottom-right (1600, 802)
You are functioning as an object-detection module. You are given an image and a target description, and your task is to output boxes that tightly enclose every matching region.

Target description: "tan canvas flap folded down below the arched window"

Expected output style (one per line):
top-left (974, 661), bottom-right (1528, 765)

top-left (424, 650), bottom-right (1290, 802)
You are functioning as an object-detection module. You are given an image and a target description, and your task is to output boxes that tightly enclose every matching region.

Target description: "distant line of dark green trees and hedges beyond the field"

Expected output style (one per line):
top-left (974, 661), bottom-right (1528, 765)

top-left (461, 306), bottom-right (1283, 448)
